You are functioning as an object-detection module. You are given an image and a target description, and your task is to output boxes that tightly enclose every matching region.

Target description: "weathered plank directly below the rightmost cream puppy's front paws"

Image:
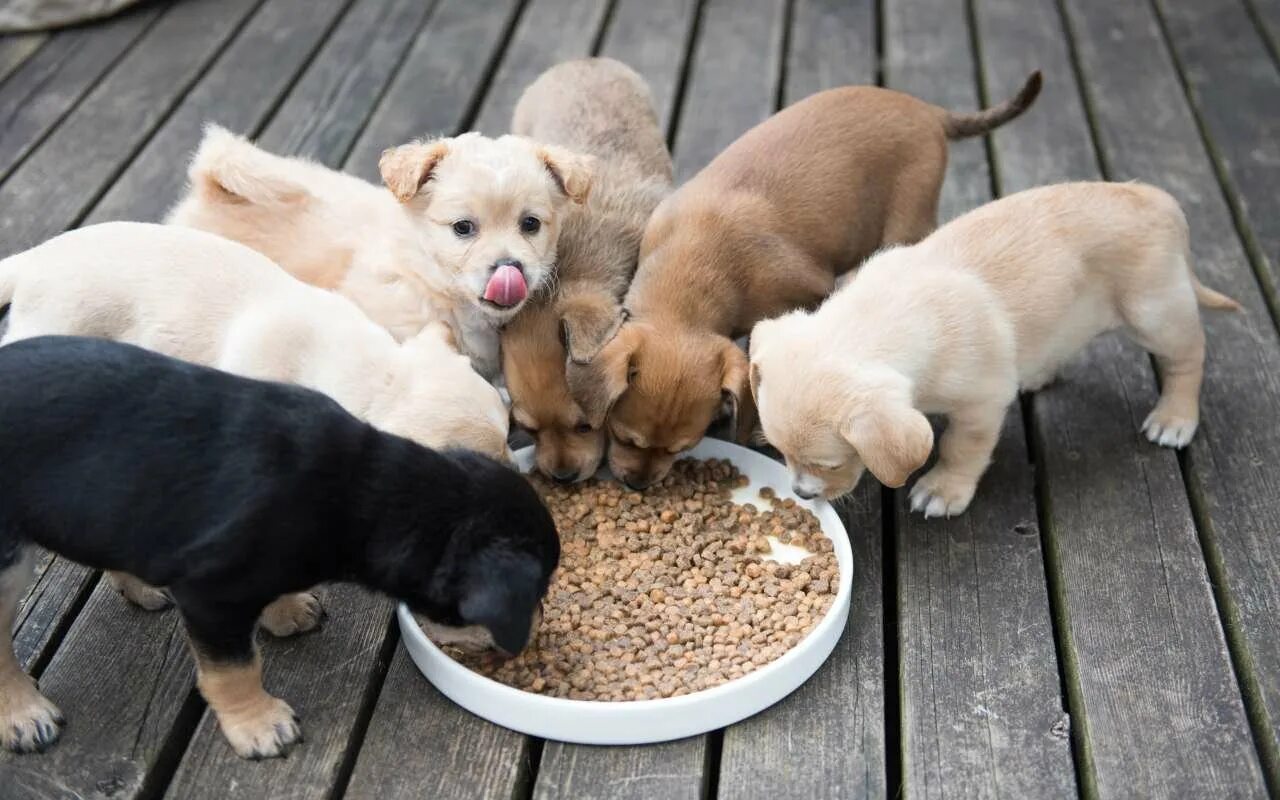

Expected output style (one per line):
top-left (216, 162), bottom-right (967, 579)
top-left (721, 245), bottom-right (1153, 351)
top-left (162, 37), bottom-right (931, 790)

top-left (897, 406), bottom-right (1076, 797)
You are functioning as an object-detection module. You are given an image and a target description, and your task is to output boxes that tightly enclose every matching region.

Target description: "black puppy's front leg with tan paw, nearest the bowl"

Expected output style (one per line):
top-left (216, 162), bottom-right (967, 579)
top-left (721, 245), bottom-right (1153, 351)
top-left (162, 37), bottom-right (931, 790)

top-left (172, 588), bottom-right (302, 759)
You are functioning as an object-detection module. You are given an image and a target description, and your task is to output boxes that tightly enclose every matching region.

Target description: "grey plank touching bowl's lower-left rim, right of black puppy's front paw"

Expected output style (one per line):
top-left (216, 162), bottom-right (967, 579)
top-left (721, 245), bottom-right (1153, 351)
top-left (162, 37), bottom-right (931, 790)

top-left (344, 646), bottom-right (531, 800)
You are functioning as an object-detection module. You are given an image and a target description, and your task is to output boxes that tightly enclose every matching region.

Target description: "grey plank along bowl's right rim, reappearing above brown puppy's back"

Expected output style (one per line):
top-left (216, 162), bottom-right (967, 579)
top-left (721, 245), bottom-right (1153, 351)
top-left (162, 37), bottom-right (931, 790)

top-left (718, 9), bottom-right (896, 797)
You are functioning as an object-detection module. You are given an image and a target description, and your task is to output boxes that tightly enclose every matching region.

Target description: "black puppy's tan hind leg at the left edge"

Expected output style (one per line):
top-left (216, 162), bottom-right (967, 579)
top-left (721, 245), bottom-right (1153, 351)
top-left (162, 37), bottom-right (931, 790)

top-left (0, 543), bottom-right (63, 753)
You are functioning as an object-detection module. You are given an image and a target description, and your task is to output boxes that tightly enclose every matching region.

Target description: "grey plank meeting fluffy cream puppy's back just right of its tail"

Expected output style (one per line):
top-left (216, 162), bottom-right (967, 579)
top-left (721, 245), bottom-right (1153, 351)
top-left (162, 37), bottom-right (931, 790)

top-left (254, 0), bottom-right (434, 165)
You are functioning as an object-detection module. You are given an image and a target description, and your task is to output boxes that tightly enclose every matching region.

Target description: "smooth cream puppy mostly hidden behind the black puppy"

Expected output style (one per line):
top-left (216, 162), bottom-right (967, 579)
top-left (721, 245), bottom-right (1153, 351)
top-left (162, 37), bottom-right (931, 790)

top-left (0, 223), bottom-right (509, 616)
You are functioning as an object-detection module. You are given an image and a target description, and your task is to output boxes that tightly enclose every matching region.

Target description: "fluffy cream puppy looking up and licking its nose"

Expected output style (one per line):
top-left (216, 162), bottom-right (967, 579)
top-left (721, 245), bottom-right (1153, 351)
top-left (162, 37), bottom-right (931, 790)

top-left (168, 125), bottom-right (591, 379)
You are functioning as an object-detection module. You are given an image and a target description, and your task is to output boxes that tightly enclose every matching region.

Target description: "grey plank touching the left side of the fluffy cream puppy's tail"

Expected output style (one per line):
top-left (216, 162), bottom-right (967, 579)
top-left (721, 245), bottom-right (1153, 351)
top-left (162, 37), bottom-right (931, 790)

top-left (86, 0), bottom-right (348, 224)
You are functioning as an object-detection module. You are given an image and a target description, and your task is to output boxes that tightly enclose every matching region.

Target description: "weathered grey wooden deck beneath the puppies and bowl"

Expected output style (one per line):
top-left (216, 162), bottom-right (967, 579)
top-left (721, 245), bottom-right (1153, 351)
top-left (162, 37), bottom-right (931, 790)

top-left (0, 0), bottom-right (1280, 800)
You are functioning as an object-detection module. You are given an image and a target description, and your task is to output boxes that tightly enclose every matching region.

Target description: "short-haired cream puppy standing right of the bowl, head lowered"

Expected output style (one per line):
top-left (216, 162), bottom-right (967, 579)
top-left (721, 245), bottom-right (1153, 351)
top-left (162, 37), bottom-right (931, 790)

top-left (750, 183), bottom-right (1239, 517)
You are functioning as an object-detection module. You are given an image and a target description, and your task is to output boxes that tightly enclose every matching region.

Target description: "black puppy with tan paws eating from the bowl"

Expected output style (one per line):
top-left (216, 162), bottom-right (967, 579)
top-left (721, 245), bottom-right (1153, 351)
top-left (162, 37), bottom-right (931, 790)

top-left (0, 337), bottom-right (559, 758)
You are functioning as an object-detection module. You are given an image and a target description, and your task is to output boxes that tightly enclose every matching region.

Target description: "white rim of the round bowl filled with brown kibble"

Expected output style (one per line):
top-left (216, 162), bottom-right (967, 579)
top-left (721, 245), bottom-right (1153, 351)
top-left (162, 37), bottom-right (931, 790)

top-left (397, 439), bottom-right (854, 745)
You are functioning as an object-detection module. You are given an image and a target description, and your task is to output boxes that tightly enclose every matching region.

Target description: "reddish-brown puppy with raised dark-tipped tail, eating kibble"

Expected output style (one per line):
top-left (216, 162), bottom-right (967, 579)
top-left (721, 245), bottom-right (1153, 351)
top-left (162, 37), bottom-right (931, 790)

top-left (568, 73), bottom-right (1041, 489)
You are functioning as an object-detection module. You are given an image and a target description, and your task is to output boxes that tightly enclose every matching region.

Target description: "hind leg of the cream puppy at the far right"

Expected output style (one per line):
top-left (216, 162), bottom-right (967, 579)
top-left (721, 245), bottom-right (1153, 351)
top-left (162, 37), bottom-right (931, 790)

top-left (1121, 277), bottom-right (1204, 448)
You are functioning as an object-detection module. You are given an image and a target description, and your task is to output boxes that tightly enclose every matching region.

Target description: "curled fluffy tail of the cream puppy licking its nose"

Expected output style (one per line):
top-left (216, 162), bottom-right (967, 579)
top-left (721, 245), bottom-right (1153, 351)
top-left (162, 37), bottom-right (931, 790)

top-left (187, 123), bottom-right (307, 205)
